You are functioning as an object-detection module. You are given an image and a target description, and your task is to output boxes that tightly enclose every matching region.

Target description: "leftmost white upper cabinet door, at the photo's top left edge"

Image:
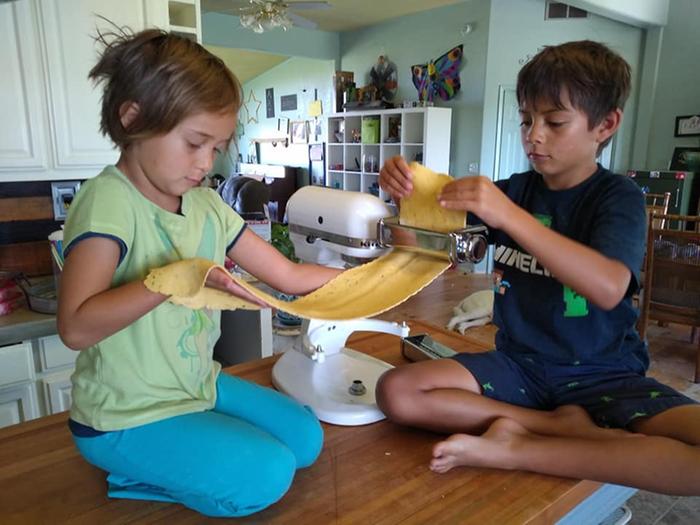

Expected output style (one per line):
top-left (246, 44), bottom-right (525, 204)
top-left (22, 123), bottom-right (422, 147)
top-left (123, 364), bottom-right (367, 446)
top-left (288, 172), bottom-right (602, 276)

top-left (0, 1), bottom-right (48, 172)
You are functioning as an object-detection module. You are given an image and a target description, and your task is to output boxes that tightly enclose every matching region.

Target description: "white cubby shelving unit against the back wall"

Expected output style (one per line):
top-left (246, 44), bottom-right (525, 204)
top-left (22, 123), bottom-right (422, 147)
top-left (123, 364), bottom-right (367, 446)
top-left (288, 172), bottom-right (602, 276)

top-left (326, 107), bottom-right (452, 200)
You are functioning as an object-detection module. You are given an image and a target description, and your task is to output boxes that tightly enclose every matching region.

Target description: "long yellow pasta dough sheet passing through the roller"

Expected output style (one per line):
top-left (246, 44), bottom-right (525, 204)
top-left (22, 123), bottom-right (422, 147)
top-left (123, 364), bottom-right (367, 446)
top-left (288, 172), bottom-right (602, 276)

top-left (145, 163), bottom-right (464, 320)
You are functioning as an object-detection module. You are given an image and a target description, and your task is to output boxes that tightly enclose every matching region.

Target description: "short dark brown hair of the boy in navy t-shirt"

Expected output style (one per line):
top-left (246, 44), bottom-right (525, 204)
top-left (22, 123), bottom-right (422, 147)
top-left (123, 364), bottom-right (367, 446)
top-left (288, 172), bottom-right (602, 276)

top-left (517, 40), bottom-right (631, 149)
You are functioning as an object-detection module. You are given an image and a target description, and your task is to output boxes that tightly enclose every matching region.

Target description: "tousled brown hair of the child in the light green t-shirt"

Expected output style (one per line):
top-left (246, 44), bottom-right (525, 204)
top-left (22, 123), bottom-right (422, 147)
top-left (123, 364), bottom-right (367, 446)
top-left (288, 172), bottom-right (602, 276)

top-left (88, 28), bottom-right (243, 149)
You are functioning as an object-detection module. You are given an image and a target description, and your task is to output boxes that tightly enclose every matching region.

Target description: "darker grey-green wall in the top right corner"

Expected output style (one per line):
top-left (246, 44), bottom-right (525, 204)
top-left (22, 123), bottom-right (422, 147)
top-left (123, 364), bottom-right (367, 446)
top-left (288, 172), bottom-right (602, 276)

top-left (634, 0), bottom-right (700, 169)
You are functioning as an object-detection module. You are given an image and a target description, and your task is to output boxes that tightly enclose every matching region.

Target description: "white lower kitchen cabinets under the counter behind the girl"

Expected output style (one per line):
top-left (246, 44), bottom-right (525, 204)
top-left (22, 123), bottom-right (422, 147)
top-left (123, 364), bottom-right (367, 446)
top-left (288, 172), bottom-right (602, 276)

top-left (0, 335), bottom-right (78, 427)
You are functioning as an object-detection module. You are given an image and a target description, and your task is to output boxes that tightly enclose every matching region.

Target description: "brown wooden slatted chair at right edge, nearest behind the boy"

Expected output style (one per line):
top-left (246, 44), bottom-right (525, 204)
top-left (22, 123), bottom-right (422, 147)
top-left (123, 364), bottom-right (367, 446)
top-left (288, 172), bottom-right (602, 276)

top-left (638, 213), bottom-right (700, 383)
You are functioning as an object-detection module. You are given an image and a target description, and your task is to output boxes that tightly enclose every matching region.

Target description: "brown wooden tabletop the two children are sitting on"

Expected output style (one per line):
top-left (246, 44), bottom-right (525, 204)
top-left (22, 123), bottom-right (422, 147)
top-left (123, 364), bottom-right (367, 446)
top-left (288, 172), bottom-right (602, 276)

top-left (0, 322), bottom-right (600, 525)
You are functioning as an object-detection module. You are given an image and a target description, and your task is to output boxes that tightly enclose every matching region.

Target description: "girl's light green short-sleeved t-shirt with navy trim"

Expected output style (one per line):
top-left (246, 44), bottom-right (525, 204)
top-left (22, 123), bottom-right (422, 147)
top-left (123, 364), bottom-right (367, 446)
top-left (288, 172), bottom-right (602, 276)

top-left (61, 166), bottom-right (245, 431)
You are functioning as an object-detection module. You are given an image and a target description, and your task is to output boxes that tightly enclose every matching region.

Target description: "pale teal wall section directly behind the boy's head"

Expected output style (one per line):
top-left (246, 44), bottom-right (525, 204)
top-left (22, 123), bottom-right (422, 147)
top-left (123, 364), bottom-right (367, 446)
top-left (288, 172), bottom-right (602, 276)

top-left (481, 0), bottom-right (643, 180)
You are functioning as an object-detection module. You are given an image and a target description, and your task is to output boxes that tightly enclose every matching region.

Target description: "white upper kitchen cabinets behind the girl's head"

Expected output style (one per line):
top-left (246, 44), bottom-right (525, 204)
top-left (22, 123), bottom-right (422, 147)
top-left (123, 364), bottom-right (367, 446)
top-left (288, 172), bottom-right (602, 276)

top-left (0, 0), bottom-right (178, 182)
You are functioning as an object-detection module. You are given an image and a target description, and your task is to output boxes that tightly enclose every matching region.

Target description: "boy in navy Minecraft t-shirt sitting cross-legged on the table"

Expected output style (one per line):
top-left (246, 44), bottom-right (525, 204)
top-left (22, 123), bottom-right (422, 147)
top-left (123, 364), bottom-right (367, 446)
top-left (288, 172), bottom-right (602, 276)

top-left (377, 41), bottom-right (700, 495)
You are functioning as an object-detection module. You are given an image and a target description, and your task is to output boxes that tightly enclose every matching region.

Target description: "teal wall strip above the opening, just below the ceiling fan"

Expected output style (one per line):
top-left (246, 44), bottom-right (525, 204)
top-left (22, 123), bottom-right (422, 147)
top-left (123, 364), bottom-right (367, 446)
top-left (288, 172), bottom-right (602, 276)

top-left (202, 13), bottom-right (340, 63)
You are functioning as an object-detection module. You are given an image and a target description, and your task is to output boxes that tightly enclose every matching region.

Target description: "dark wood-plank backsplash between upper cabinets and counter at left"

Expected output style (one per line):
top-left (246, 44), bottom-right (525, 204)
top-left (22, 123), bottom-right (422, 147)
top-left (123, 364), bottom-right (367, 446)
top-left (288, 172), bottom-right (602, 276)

top-left (0, 181), bottom-right (67, 276)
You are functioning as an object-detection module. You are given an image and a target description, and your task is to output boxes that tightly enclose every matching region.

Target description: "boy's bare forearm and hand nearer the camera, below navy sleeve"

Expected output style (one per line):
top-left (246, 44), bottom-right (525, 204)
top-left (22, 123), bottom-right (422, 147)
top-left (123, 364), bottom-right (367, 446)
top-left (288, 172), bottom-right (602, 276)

top-left (438, 177), bottom-right (632, 310)
